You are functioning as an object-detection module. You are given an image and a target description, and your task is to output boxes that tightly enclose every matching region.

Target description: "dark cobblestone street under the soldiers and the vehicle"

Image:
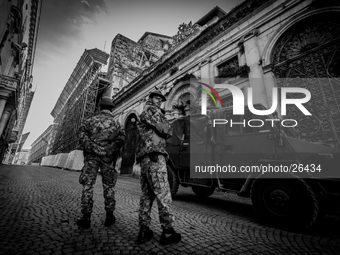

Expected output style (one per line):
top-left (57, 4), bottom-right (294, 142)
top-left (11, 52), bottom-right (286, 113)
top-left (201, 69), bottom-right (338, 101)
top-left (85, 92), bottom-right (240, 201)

top-left (0, 165), bottom-right (340, 254)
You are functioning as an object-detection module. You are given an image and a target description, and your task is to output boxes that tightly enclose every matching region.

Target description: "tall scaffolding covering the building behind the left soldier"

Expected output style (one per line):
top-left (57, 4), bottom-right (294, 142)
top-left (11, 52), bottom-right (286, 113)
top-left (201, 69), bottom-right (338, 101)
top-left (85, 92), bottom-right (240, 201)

top-left (51, 49), bottom-right (110, 154)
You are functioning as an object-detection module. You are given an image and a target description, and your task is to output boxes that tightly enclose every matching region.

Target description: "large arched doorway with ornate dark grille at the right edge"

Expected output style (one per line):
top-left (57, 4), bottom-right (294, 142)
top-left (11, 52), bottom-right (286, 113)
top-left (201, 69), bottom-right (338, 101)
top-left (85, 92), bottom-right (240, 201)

top-left (271, 12), bottom-right (340, 147)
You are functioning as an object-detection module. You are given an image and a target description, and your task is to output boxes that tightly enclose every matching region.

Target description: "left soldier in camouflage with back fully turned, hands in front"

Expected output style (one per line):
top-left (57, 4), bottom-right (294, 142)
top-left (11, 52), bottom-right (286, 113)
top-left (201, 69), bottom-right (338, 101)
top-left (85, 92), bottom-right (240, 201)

top-left (77, 100), bottom-right (125, 228)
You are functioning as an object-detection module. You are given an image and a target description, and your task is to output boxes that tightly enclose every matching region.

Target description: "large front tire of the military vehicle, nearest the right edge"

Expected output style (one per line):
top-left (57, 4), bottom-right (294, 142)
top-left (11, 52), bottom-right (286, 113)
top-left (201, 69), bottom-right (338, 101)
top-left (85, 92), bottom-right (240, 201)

top-left (250, 176), bottom-right (319, 230)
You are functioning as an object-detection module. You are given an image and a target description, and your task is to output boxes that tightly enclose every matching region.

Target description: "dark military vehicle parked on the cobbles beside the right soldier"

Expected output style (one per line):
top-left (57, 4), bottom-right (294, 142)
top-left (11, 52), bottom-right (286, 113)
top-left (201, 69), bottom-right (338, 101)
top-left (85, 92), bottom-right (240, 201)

top-left (167, 104), bottom-right (340, 229)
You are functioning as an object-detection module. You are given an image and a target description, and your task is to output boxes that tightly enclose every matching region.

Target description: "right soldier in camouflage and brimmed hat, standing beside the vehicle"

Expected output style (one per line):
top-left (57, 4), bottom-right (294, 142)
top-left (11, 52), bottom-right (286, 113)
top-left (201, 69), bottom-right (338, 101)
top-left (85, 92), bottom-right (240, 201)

top-left (136, 91), bottom-right (181, 244)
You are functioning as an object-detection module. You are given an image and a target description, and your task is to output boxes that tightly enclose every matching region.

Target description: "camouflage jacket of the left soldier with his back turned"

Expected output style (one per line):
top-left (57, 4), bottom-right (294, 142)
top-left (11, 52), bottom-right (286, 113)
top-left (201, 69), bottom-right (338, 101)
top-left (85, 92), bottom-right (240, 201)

top-left (79, 110), bottom-right (125, 162)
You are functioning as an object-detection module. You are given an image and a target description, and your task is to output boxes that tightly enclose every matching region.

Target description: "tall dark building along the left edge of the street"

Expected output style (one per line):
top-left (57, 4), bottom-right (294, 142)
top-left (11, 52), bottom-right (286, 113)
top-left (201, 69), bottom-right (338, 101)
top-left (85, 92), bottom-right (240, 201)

top-left (0, 0), bottom-right (42, 163)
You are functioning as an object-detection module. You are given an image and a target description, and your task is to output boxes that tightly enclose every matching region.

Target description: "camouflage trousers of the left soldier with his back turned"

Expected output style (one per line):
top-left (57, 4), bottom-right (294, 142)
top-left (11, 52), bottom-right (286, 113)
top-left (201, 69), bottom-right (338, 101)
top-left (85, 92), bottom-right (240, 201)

top-left (79, 159), bottom-right (118, 213)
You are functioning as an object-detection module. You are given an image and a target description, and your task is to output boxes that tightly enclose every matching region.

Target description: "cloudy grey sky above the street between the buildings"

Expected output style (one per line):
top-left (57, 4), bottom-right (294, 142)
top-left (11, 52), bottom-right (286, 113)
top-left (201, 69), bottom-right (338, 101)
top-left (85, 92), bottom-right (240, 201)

top-left (23, 0), bottom-right (242, 149)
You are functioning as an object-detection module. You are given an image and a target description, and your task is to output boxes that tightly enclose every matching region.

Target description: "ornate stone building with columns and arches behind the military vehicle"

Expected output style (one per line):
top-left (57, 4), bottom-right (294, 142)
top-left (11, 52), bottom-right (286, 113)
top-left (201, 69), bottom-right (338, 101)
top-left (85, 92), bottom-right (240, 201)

top-left (109, 0), bottom-right (340, 173)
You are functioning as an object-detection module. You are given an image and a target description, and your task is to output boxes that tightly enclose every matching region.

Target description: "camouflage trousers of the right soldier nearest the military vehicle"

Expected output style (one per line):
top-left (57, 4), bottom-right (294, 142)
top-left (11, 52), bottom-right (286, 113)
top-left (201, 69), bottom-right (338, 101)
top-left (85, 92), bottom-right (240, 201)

top-left (139, 155), bottom-right (173, 229)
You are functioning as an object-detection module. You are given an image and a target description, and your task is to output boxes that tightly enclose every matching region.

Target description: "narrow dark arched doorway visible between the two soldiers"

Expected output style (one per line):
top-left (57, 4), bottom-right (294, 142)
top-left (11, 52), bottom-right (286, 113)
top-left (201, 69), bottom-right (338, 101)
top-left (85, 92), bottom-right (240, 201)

top-left (121, 113), bottom-right (138, 174)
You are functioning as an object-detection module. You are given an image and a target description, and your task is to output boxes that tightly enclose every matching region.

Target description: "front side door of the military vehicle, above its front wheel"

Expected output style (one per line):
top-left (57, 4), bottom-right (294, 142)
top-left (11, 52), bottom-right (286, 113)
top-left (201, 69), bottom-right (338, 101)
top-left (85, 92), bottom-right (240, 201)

top-left (216, 108), bottom-right (276, 190)
